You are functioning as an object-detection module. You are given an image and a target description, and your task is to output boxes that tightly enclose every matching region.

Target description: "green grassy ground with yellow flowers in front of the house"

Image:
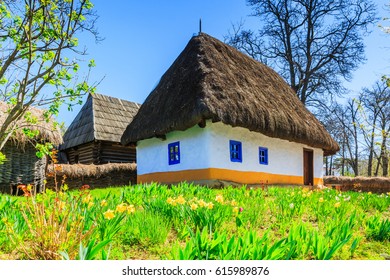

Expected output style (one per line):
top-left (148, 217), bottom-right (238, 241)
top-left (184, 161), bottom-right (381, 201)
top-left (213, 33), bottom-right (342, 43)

top-left (0, 183), bottom-right (390, 260)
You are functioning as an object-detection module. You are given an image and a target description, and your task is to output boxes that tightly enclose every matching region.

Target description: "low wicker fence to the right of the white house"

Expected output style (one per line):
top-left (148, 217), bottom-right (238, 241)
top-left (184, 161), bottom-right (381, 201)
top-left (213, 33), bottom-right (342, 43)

top-left (324, 176), bottom-right (390, 193)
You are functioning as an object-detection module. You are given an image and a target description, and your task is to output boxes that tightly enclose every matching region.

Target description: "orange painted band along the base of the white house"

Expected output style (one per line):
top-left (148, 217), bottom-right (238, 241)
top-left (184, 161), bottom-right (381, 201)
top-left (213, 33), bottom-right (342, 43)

top-left (137, 168), bottom-right (323, 185)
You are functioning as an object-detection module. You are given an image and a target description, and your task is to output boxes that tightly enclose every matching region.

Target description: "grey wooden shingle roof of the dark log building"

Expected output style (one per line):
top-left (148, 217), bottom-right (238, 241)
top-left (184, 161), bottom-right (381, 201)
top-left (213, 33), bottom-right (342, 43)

top-left (61, 93), bottom-right (140, 150)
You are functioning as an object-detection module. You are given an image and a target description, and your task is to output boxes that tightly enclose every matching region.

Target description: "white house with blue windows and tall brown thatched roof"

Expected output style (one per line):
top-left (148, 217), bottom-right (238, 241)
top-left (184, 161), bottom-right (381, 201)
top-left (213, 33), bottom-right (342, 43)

top-left (122, 34), bottom-right (339, 185)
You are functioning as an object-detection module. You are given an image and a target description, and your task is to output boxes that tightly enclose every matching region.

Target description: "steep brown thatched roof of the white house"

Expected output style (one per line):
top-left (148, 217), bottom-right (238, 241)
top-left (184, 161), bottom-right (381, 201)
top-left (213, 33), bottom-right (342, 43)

top-left (122, 33), bottom-right (339, 154)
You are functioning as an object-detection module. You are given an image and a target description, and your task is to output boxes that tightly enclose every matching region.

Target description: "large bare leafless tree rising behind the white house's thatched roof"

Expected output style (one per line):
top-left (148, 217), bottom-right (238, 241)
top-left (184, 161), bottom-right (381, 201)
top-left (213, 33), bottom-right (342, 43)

top-left (225, 0), bottom-right (377, 105)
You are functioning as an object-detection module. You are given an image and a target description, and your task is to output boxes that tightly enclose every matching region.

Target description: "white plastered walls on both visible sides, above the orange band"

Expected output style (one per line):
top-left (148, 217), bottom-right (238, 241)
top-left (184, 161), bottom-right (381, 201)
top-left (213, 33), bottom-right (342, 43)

top-left (137, 121), bottom-right (323, 178)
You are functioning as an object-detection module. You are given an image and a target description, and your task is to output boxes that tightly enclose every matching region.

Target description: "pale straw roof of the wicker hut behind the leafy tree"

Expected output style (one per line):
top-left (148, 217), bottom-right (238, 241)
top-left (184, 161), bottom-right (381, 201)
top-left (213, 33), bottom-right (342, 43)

top-left (0, 101), bottom-right (62, 145)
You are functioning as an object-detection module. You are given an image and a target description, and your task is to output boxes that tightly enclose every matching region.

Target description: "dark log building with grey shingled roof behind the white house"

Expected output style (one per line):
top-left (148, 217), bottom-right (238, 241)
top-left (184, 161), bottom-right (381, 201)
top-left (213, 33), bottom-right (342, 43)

top-left (60, 93), bottom-right (140, 164)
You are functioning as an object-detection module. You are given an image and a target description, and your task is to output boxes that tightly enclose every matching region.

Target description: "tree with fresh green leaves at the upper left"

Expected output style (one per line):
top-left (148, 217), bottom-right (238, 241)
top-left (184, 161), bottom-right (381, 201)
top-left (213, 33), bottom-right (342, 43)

top-left (0, 0), bottom-right (99, 158)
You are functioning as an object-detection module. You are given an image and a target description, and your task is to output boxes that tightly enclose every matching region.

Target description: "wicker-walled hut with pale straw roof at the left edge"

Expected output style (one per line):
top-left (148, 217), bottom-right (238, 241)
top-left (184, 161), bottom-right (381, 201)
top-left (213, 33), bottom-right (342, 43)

top-left (0, 101), bottom-right (62, 193)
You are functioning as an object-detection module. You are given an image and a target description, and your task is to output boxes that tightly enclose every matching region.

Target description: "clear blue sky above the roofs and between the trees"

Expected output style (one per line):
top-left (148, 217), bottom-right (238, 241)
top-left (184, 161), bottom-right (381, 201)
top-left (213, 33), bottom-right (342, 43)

top-left (58, 0), bottom-right (390, 126)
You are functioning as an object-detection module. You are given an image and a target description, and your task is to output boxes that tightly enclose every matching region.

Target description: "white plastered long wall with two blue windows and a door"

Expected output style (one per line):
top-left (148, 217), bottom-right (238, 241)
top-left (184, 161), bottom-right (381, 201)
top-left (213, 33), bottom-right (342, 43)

top-left (209, 123), bottom-right (323, 178)
